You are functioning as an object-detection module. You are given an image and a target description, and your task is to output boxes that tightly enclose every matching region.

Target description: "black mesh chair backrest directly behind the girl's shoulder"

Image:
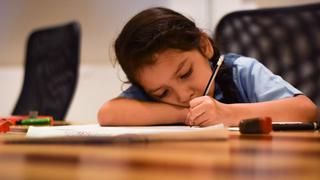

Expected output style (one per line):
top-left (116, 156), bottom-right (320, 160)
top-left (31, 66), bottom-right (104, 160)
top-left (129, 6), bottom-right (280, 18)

top-left (213, 3), bottom-right (320, 105)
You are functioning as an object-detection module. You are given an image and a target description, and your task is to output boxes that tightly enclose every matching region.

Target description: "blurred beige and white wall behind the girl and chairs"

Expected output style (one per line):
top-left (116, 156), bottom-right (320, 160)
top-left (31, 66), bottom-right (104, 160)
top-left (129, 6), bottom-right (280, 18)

top-left (0, 0), bottom-right (320, 123)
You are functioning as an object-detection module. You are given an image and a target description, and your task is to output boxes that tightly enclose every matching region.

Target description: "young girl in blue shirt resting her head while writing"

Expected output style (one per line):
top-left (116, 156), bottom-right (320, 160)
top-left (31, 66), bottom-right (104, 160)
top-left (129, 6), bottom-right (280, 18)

top-left (98, 8), bottom-right (317, 126)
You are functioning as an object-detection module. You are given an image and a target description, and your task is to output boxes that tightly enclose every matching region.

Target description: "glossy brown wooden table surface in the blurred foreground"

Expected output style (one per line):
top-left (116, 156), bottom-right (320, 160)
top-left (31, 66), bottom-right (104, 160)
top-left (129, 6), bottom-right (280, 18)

top-left (0, 131), bottom-right (320, 180)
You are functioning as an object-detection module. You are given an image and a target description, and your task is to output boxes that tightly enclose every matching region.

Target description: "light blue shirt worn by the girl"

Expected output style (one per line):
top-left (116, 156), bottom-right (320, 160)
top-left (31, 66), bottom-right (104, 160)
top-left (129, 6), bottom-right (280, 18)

top-left (120, 54), bottom-right (303, 103)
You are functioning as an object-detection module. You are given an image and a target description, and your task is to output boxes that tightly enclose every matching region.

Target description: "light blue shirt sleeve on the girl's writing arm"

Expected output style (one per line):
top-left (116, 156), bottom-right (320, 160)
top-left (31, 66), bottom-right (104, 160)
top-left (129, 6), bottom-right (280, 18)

top-left (233, 57), bottom-right (302, 102)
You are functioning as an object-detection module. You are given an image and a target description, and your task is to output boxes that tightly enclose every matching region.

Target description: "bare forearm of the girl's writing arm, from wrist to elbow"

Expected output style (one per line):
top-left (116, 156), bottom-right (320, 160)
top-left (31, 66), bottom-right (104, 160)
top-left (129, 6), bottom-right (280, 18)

top-left (226, 95), bottom-right (318, 125)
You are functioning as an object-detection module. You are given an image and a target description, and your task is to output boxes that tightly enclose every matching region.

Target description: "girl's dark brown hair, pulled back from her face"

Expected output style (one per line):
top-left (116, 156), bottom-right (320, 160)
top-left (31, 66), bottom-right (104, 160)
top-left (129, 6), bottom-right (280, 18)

top-left (114, 7), bottom-right (240, 103)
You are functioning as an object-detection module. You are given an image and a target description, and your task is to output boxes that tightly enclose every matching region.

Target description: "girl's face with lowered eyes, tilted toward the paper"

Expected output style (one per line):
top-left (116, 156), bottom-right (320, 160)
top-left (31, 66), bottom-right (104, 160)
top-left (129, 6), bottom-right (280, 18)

top-left (139, 49), bottom-right (214, 107)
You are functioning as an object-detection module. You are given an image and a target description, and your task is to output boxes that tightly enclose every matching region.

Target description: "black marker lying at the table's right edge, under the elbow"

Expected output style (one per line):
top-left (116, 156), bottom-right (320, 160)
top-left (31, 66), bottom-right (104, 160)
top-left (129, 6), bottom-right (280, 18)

top-left (272, 122), bottom-right (319, 131)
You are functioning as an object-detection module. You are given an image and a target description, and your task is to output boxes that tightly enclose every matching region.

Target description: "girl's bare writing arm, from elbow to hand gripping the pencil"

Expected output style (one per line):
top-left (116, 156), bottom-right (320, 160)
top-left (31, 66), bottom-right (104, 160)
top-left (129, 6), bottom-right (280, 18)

top-left (186, 95), bottom-right (317, 126)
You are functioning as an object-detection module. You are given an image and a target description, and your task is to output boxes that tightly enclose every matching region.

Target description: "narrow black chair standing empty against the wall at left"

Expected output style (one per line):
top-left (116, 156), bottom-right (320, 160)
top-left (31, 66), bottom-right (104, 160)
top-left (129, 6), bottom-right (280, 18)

top-left (12, 22), bottom-right (80, 120)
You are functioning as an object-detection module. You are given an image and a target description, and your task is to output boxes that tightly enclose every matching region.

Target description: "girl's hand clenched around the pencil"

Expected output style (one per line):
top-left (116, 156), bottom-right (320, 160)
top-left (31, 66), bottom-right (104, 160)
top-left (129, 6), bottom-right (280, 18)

top-left (185, 96), bottom-right (230, 127)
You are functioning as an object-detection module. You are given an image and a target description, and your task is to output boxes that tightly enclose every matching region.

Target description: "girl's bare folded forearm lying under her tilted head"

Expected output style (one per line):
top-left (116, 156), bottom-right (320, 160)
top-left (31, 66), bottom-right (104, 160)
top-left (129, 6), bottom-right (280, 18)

top-left (98, 98), bottom-right (188, 126)
